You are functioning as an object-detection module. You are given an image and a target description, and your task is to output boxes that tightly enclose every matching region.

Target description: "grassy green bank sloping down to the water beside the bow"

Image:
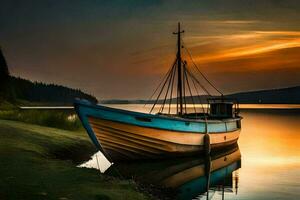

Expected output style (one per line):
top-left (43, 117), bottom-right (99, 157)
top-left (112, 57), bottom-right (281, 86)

top-left (0, 120), bottom-right (148, 200)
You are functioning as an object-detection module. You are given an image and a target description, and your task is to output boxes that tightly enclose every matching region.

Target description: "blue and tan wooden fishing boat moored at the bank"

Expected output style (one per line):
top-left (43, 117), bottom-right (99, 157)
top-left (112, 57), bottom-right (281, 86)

top-left (74, 23), bottom-right (242, 162)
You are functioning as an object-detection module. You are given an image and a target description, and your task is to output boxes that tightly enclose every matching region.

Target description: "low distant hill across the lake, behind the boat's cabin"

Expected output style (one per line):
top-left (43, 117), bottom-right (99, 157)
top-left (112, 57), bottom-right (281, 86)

top-left (100, 86), bottom-right (300, 104)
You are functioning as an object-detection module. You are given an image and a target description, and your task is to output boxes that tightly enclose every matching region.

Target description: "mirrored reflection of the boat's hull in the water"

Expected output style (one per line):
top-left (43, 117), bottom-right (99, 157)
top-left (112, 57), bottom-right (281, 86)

top-left (107, 144), bottom-right (241, 199)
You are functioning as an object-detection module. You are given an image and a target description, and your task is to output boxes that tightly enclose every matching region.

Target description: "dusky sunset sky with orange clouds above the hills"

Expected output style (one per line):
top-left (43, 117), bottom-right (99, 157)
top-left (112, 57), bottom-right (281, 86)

top-left (0, 0), bottom-right (300, 100)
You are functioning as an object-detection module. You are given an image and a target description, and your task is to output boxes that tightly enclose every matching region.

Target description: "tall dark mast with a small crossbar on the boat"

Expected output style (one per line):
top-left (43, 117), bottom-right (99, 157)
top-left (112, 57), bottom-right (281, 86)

top-left (173, 22), bottom-right (184, 115)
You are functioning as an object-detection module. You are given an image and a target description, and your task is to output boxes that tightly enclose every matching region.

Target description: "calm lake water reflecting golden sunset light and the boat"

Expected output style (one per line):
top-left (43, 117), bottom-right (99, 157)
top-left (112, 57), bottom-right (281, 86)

top-left (84, 105), bottom-right (300, 200)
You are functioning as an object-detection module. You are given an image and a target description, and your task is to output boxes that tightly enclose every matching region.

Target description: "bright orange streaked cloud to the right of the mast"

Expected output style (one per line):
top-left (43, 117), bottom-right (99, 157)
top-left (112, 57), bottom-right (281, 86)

top-left (186, 31), bottom-right (300, 63)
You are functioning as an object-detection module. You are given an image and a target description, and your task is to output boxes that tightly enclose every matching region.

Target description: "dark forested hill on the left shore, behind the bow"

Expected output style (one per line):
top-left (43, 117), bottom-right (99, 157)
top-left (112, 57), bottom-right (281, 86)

top-left (0, 49), bottom-right (97, 105)
